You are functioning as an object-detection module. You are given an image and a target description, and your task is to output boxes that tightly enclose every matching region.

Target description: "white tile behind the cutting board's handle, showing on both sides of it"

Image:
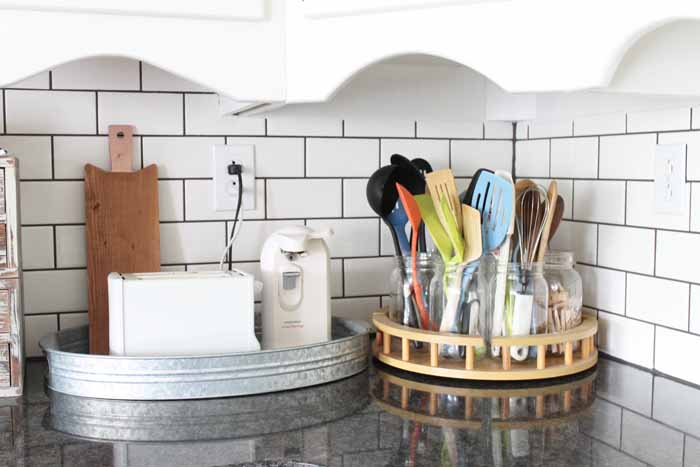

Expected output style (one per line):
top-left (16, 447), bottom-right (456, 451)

top-left (53, 136), bottom-right (141, 179)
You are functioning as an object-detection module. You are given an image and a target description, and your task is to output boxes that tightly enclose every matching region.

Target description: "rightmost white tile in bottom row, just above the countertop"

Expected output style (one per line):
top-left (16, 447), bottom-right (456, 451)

top-left (655, 327), bottom-right (700, 384)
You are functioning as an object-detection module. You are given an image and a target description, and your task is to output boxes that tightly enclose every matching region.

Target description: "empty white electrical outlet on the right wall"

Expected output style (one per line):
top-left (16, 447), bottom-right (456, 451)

top-left (654, 144), bottom-right (686, 214)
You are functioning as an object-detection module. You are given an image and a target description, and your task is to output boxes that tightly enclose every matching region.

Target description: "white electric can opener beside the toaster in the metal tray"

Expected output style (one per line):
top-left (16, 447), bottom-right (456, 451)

top-left (260, 226), bottom-right (332, 350)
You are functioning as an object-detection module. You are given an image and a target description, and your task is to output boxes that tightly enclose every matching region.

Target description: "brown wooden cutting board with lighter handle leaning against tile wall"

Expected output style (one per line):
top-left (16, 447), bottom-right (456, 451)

top-left (85, 125), bottom-right (160, 355)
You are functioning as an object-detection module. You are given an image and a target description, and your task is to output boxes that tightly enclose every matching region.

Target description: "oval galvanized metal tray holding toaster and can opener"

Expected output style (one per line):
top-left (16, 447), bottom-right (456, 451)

top-left (39, 318), bottom-right (369, 400)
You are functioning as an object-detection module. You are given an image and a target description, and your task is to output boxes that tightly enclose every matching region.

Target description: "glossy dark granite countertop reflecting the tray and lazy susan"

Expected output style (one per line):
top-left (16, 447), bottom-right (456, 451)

top-left (0, 360), bottom-right (700, 467)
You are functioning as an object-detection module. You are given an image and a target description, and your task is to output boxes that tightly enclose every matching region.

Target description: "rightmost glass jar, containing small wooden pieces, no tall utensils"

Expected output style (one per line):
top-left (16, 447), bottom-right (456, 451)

top-left (544, 251), bottom-right (583, 353)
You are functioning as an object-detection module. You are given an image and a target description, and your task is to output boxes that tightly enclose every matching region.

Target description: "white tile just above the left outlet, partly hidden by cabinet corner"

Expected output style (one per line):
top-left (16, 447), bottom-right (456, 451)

top-left (185, 94), bottom-right (265, 135)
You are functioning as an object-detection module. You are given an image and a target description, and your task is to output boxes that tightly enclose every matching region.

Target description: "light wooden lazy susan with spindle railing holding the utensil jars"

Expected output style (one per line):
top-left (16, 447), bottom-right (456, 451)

top-left (372, 311), bottom-right (598, 381)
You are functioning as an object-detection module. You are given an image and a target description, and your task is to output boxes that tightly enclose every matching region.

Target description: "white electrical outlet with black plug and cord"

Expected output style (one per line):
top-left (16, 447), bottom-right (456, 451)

top-left (212, 144), bottom-right (255, 212)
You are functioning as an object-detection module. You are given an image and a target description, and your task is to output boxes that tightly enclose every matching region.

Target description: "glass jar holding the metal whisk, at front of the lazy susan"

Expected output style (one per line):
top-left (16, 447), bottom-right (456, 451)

top-left (488, 263), bottom-right (548, 361)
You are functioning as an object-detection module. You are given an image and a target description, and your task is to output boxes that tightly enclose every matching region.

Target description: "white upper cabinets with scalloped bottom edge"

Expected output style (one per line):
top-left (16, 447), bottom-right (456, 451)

top-left (0, 0), bottom-right (700, 112)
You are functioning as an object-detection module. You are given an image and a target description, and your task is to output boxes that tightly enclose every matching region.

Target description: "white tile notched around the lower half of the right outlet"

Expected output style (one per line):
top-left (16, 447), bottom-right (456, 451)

top-left (627, 182), bottom-right (700, 234)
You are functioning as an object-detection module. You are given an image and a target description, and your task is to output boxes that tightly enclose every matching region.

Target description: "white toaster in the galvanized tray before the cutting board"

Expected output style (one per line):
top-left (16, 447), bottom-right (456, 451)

top-left (108, 271), bottom-right (260, 357)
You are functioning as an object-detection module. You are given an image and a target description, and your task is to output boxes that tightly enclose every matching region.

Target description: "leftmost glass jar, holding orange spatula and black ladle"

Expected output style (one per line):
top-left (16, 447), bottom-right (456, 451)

top-left (388, 253), bottom-right (443, 328)
